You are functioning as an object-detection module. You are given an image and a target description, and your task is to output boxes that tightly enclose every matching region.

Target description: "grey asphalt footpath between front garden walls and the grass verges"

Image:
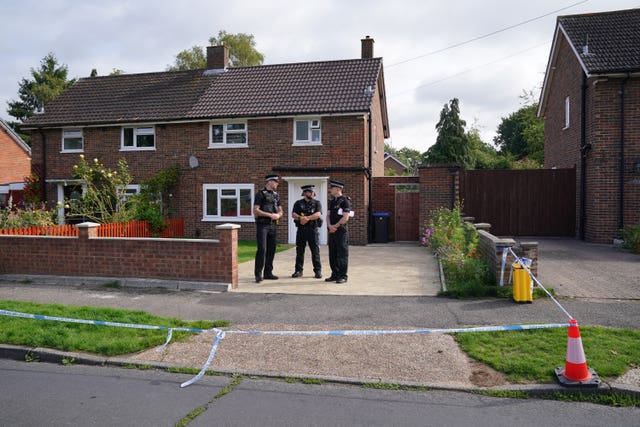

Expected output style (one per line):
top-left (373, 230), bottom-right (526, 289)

top-left (0, 282), bottom-right (640, 329)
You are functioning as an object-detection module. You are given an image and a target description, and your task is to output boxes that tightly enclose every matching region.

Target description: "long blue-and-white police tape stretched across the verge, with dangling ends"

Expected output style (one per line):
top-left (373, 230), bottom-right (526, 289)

top-left (0, 310), bottom-right (569, 387)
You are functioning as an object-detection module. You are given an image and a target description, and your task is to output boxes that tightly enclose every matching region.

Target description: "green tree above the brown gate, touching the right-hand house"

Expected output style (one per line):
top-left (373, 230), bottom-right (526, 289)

top-left (493, 92), bottom-right (544, 164)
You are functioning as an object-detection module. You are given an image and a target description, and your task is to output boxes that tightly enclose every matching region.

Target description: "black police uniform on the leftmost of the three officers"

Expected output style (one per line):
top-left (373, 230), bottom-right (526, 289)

top-left (254, 188), bottom-right (280, 280)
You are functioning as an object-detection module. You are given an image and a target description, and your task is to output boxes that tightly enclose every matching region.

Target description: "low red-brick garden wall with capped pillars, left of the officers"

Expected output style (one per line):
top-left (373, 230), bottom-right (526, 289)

top-left (0, 223), bottom-right (238, 287)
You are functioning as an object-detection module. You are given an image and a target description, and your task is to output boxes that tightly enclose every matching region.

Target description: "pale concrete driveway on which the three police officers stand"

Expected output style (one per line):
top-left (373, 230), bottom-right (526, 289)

top-left (233, 242), bottom-right (440, 296)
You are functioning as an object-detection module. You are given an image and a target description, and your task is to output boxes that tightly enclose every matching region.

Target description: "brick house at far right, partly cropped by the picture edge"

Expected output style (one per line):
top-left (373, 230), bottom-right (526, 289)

top-left (538, 9), bottom-right (640, 243)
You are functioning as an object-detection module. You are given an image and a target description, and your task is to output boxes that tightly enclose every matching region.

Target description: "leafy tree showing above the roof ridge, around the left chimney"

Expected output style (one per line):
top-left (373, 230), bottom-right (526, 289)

top-left (167, 30), bottom-right (264, 71)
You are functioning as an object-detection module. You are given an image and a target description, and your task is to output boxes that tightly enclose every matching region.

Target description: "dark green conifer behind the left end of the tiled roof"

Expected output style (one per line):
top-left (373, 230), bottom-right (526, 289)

top-left (7, 53), bottom-right (75, 122)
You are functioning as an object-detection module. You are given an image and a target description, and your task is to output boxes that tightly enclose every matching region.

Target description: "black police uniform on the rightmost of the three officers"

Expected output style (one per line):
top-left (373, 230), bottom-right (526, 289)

top-left (327, 195), bottom-right (351, 280)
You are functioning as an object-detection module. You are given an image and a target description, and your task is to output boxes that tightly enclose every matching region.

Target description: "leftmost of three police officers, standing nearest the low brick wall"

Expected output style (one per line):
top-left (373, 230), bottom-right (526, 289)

top-left (253, 175), bottom-right (282, 283)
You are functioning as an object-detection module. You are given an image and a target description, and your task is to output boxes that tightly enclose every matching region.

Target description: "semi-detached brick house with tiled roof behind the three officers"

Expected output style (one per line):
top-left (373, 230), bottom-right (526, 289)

top-left (26, 36), bottom-right (389, 245)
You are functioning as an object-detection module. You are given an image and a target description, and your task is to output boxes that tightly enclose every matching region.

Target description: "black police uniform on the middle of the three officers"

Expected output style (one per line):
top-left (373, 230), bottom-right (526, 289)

top-left (293, 198), bottom-right (322, 278)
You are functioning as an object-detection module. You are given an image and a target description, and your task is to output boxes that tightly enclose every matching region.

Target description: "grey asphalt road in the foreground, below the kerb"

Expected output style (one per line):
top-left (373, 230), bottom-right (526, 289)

top-left (0, 360), bottom-right (640, 427)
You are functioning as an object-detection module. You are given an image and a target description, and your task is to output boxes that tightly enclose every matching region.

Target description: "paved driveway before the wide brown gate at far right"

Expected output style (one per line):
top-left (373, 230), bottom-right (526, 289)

top-left (532, 238), bottom-right (640, 300)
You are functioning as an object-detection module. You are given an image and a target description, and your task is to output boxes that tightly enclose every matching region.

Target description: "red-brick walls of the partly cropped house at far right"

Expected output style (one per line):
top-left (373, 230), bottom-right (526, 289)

top-left (543, 32), bottom-right (640, 243)
